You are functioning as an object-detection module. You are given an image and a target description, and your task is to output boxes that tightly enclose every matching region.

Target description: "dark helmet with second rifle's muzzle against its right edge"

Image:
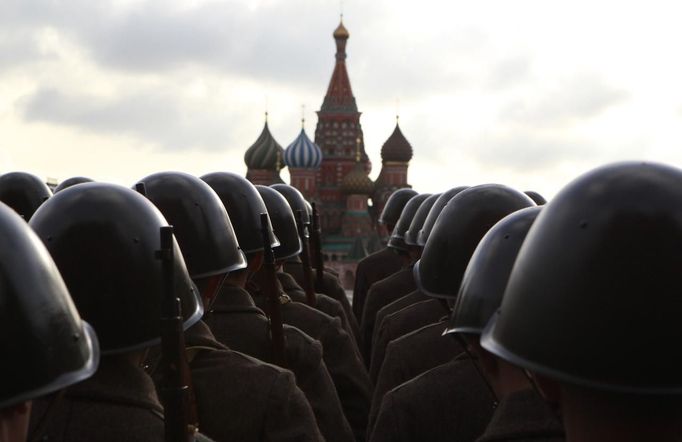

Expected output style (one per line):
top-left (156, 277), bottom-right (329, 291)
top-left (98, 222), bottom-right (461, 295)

top-left (201, 172), bottom-right (279, 254)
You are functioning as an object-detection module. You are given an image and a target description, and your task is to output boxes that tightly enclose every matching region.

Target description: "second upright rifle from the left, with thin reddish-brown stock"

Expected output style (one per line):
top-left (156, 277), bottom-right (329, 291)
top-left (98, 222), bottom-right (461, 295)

top-left (260, 213), bottom-right (286, 367)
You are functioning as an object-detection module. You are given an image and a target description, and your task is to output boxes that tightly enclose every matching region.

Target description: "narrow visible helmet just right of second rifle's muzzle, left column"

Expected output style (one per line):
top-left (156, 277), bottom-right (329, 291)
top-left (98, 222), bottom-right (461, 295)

top-left (256, 186), bottom-right (302, 261)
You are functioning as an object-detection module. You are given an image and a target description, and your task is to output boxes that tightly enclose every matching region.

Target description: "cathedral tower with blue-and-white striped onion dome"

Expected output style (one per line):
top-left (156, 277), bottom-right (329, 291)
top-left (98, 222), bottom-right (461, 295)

top-left (284, 118), bottom-right (322, 201)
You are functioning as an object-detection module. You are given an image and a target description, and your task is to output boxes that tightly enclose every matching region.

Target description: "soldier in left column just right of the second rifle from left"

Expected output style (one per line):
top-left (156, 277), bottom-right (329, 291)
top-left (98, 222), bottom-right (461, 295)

top-left (254, 186), bottom-right (371, 440)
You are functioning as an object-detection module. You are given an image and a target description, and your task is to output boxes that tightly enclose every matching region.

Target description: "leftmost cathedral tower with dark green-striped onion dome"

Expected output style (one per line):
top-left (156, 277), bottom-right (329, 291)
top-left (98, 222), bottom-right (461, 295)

top-left (244, 112), bottom-right (284, 186)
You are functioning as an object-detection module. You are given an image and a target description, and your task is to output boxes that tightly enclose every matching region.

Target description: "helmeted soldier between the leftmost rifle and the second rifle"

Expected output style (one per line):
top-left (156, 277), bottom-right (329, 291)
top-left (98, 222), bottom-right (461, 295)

top-left (141, 172), bottom-right (322, 441)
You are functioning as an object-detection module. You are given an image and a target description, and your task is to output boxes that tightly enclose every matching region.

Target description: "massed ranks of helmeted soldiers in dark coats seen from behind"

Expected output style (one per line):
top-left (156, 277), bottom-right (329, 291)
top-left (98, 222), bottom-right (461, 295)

top-left (0, 163), bottom-right (682, 442)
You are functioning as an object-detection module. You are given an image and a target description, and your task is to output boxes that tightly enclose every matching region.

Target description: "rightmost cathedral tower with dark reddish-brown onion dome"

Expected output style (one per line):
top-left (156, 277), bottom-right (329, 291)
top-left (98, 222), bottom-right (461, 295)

top-left (372, 116), bottom-right (412, 218)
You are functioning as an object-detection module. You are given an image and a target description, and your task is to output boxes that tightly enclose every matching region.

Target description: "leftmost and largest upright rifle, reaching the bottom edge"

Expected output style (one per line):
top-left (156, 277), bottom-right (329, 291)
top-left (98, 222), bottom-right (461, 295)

top-left (156, 226), bottom-right (198, 442)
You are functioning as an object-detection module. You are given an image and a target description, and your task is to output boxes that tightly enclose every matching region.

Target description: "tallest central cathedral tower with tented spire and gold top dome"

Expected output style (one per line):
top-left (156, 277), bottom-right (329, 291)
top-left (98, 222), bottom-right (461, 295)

top-left (315, 17), bottom-right (371, 234)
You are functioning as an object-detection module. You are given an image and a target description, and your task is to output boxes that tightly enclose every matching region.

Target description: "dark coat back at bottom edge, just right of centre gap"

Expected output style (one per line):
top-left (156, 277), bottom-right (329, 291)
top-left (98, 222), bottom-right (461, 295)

top-left (370, 358), bottom-right (494, 442)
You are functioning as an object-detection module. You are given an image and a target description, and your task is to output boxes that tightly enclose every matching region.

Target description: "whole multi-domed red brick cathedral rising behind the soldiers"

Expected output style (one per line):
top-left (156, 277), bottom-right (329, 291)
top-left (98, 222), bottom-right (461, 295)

top-left (244, 21), bottom-right (412, 288)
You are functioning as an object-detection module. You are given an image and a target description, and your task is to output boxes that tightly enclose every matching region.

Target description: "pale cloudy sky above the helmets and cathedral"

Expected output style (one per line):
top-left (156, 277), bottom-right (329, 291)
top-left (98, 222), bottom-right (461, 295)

top-left (0, 0), bottom-right (682, 196)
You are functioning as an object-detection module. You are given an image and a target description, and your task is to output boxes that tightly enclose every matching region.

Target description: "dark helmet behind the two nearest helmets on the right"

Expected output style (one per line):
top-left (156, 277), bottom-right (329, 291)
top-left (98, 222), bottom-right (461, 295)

top-left (414, 184), bottom-right (535, 298)
